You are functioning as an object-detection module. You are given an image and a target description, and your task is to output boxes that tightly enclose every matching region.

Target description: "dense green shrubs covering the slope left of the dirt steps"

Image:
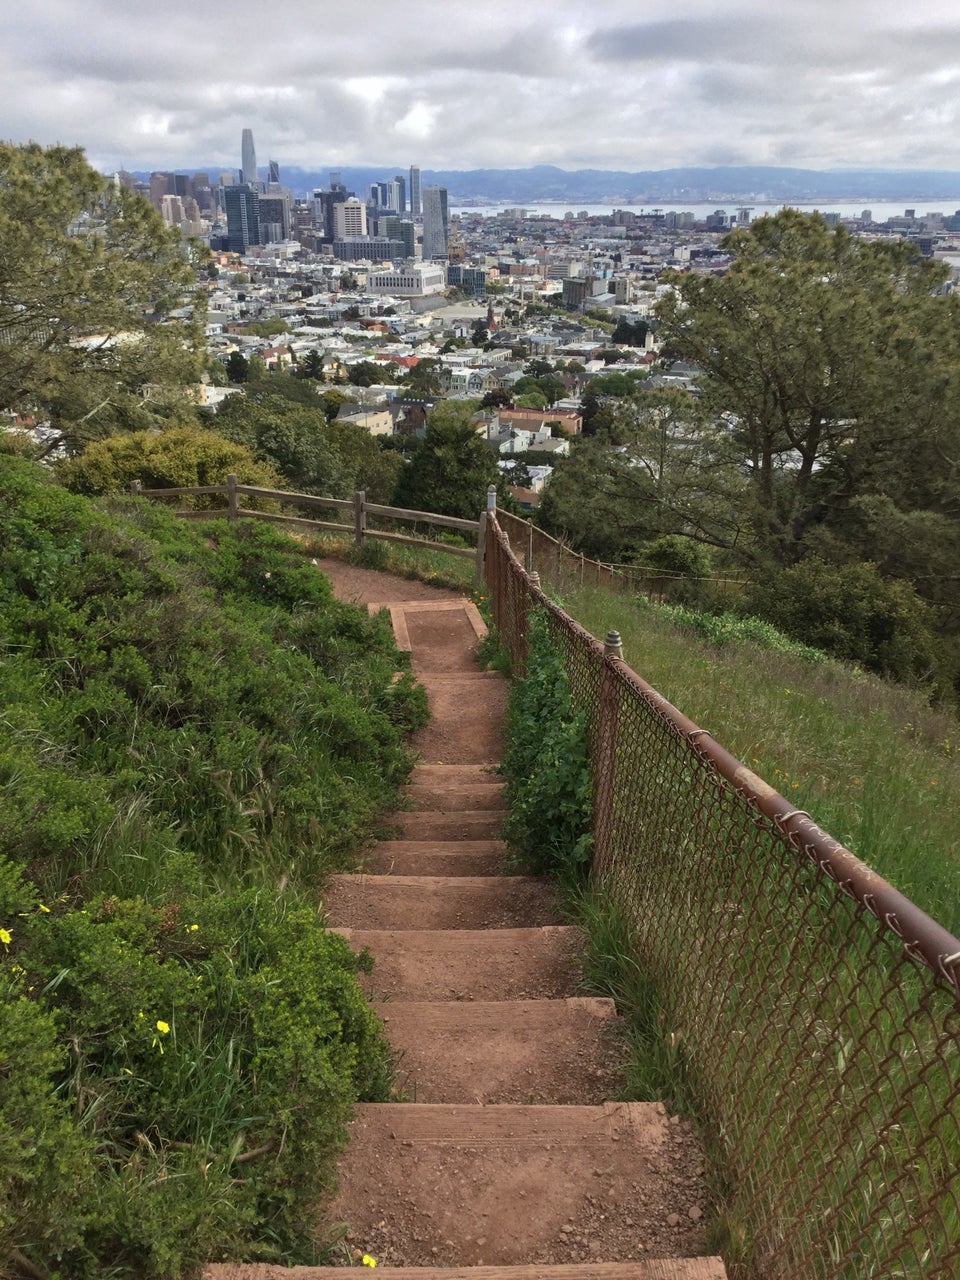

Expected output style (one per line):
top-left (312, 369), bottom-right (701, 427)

top-left (0, 458), bottom-right (425, 1277)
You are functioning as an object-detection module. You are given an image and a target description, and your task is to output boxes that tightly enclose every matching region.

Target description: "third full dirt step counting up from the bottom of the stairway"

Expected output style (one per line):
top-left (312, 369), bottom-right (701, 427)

top-left (337, 924), bottom-right (584, 1001)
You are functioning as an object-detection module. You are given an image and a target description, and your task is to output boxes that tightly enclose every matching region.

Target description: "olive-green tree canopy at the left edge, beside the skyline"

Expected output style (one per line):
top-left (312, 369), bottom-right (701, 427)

top-left (0, 143), bottom-right (202, 451)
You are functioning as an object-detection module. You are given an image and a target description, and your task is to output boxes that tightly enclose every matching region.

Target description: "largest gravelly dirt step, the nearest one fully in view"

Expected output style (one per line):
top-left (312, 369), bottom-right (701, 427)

top-left (325, 1102), bottom-right (709, 1266)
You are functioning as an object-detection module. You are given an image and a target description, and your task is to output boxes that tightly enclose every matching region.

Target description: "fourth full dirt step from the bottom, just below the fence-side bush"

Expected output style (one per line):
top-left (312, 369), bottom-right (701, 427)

top-left (324, 874), bottom-right (558, 929)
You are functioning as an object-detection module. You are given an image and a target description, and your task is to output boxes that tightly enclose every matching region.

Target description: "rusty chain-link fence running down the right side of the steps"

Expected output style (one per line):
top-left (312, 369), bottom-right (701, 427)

top-left (486, 514), bottom-right (960, 1280)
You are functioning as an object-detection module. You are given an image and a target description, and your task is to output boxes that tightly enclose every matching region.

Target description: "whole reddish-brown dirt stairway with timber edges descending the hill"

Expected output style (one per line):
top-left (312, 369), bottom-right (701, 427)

top-left (206, 562), bottom-right (724, 1280)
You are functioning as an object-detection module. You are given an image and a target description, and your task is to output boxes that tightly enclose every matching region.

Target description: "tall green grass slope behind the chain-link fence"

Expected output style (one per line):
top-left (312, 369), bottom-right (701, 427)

top-left (563, 589), bottom-right (960, 933)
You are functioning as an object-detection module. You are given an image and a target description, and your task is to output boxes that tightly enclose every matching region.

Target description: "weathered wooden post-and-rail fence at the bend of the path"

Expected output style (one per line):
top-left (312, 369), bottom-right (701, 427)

top-left (131, 474), bottom-right (486, 579)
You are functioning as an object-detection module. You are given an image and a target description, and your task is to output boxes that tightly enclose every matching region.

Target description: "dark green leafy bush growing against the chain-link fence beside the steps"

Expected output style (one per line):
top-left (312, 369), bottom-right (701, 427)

top-left (500, 608), bottom-right (593, 877)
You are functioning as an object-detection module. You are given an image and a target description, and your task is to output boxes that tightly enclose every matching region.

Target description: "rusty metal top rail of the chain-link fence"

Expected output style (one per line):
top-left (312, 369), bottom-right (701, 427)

top-left (493, 522), bottom-right (960, 997)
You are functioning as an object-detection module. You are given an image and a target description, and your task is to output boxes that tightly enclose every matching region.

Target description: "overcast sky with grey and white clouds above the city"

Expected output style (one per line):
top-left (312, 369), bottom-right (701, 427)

top-left (0, 0), bottom-right (960, 172)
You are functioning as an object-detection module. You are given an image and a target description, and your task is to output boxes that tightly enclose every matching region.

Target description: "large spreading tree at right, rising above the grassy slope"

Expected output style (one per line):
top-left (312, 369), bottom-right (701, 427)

top-left (658, 210), bottom-right (960, 564)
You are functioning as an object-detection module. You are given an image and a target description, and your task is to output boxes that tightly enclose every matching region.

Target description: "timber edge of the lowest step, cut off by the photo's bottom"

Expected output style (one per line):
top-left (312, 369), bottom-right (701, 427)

top-left (204, 1251), bottom-right (727, 1280)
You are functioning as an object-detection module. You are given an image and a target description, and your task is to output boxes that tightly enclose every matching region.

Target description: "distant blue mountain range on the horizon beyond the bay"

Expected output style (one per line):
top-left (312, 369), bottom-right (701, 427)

top-left (137, 165), bottom-right (960, 207)
